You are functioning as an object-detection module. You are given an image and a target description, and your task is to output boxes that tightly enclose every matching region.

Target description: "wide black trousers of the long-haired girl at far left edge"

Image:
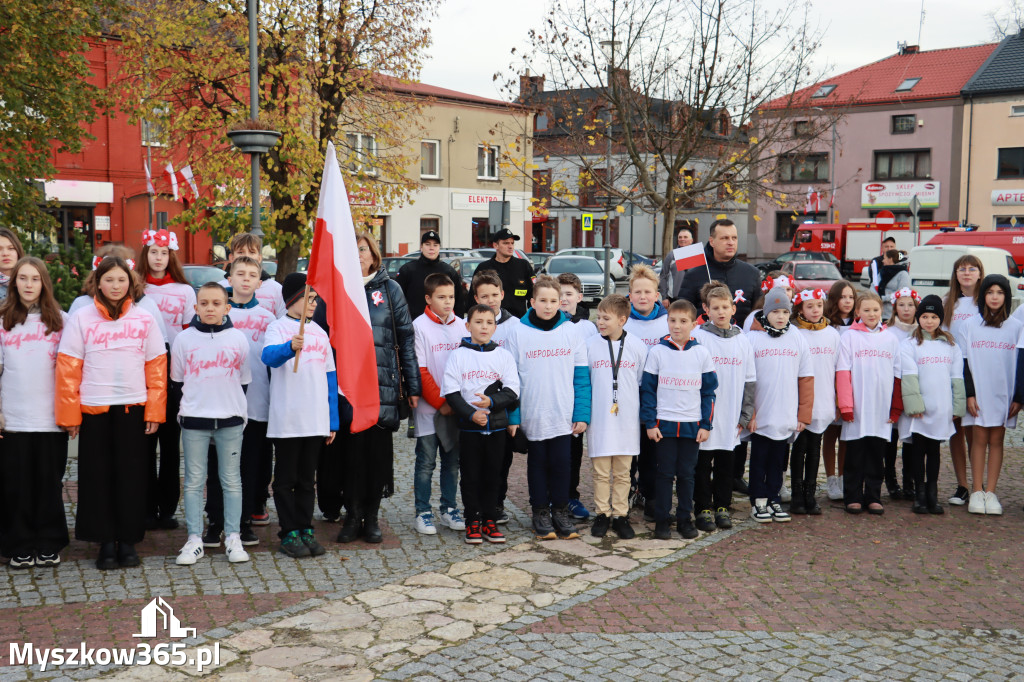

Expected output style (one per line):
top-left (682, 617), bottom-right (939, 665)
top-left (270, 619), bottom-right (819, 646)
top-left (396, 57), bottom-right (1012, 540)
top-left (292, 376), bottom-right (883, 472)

top-left (0, 431), bottom-right (68, 556)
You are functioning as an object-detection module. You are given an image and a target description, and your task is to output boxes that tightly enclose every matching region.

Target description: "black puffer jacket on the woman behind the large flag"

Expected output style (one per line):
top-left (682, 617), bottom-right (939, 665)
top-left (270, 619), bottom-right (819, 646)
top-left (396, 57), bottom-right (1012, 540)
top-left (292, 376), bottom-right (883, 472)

top-left (313, 269), bottom-right (422, 431)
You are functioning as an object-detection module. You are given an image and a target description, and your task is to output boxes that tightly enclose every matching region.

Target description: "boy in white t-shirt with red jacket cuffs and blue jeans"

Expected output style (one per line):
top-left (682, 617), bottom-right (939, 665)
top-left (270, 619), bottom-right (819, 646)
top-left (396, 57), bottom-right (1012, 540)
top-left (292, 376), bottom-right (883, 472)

top-left (413, 272), bottom-right (466, 536)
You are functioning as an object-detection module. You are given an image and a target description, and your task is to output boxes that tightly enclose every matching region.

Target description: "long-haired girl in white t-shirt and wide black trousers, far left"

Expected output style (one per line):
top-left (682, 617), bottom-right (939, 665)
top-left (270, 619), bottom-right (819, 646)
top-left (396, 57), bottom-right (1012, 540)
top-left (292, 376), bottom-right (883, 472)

top-left (0, 256), bottom-right (69, 568)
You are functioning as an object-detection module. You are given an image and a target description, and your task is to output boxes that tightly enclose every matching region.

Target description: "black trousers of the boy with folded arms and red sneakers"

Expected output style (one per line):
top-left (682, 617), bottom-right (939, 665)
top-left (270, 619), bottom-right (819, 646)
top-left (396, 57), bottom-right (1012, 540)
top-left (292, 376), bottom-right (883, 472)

top-left (459, 429), bottom-right (508, 521)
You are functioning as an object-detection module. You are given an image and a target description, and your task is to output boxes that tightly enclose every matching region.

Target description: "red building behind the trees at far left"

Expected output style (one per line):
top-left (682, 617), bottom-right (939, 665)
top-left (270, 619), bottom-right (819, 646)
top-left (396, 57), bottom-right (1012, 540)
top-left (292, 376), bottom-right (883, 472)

top-left (45, 39), bottom-right (213, 263)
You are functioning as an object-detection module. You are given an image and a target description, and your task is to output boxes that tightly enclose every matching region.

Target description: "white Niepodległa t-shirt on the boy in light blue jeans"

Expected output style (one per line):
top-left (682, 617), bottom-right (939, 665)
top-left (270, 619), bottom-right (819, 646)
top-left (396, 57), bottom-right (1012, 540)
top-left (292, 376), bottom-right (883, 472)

top-left (171, 327), bottom-right (252, 419)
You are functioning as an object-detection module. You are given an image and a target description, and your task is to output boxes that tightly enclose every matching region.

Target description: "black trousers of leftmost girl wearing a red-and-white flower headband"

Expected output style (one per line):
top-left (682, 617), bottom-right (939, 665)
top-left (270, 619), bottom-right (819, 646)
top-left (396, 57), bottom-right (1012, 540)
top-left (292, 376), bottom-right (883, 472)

top-left (145, 376), bottom-right (181, 518)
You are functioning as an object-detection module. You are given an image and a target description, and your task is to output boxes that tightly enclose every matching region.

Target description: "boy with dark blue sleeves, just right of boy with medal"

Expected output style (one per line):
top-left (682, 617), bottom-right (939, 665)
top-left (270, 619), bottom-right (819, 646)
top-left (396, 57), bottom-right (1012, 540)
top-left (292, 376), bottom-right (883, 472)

top-left (640, 299), bottom-right (718, 540)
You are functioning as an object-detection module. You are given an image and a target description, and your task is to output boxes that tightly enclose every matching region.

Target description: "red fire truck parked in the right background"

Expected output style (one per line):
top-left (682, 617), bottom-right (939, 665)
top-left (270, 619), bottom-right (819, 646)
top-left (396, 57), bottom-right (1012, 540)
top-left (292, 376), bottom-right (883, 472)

top-left (790, 217), bottom-right (963, 279)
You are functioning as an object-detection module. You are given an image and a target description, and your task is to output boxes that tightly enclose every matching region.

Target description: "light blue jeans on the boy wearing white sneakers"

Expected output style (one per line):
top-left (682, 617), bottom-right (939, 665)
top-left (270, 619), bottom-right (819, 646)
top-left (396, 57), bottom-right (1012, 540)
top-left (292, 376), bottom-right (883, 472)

top-left (181, 424), bottom-right (245, 536)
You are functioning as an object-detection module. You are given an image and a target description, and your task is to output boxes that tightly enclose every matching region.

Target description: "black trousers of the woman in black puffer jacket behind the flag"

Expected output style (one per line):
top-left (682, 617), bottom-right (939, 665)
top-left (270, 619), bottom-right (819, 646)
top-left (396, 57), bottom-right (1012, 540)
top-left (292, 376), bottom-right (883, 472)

top-left (342, 426), bottom-right (394, 512)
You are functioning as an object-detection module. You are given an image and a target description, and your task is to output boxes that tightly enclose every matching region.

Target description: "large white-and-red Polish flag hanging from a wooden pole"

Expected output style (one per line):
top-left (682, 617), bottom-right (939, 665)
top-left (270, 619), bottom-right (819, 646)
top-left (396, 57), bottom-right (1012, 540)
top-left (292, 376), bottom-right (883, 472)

top-left (306, 142), bottom-right (380, 433)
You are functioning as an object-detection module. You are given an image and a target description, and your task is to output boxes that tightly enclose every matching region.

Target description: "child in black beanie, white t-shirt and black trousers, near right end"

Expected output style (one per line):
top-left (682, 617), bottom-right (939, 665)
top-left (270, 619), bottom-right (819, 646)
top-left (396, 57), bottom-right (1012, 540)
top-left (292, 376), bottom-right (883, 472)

top-left (899, 295), bottom-right (967, 514)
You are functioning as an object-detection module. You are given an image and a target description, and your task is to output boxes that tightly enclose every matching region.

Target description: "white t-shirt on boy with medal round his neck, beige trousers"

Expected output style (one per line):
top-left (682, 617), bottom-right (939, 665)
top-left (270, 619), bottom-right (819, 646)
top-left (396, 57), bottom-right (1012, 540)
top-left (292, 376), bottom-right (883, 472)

top-left (587, 332), bottom-right (647, 457)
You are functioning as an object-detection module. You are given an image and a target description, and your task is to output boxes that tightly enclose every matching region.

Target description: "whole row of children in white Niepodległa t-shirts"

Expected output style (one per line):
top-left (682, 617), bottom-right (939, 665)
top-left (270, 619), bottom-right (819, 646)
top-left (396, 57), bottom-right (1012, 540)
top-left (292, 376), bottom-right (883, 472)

top-left (0, 230), bottom-right (1024, 568)
